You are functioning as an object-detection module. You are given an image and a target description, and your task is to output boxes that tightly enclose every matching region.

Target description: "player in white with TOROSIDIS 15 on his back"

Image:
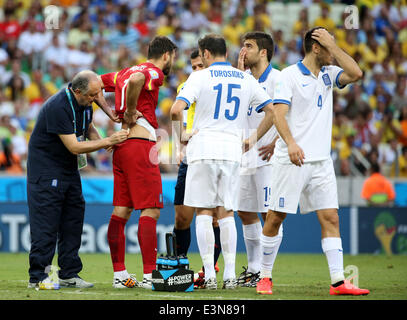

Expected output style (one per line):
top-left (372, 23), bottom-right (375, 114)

top-left (171, 35), bottom-right (272, 289)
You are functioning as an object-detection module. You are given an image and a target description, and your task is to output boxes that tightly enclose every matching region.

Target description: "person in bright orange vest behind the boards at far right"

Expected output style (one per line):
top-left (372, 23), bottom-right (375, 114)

top-left (361, 163), bottom-right (396, 206)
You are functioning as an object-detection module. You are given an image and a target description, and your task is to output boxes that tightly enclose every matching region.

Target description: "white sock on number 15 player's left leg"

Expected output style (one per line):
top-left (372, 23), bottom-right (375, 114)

top-left (195, 215), bottom-right (217, 280)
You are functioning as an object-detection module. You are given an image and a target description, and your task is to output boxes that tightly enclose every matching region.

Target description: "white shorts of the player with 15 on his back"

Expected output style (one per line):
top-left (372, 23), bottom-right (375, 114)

top-left (184, 160), bottom-right (239, 210)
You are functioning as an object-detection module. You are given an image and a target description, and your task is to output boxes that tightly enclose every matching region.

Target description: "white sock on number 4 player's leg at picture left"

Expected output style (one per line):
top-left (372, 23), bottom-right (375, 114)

top-left (260, 224), bottom-right (283, 279)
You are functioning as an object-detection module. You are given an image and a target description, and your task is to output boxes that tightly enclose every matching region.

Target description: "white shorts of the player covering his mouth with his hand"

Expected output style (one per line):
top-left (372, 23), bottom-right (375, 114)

top-left (237, 165), bottom-right (271, 212)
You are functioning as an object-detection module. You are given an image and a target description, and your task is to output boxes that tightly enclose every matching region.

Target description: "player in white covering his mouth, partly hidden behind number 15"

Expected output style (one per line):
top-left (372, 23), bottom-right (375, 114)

top-left (238, 31), bottom-right (283, 287)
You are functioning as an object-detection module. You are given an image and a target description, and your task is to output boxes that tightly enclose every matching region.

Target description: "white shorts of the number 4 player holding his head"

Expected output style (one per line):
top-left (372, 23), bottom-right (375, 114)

top-left (269, 159), bottom-right (339, 213)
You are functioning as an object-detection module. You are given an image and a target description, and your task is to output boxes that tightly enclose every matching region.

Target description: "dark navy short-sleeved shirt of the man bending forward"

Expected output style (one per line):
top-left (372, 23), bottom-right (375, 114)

top-left (27, 88), bottom-right (93, 182)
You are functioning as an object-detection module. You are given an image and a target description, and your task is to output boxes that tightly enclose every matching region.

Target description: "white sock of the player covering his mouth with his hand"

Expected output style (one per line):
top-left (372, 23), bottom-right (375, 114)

top-left (243, 221), bottom-right (263, 273)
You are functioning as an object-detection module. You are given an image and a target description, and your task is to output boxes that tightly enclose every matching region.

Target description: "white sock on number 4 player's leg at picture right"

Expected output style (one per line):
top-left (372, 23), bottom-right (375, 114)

top-left (321, 238), bottom-right (345, 284)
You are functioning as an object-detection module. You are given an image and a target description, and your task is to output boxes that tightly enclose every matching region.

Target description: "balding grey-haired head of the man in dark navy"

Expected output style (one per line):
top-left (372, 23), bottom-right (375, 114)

top-left (72, 70), bottom-right (102, 106)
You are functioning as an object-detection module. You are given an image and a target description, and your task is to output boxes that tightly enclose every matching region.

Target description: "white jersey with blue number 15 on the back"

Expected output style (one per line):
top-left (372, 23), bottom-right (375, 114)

top-left (177, 62), bottom-right (271, 162)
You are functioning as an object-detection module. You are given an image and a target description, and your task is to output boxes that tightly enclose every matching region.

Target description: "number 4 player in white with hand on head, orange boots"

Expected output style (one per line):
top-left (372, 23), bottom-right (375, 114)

top-left (257, 27), bottom-right (369, 295)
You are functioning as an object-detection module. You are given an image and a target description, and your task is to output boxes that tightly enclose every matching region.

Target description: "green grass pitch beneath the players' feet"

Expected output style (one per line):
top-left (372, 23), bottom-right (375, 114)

top-left (0, 253), bottom-right (407, 301)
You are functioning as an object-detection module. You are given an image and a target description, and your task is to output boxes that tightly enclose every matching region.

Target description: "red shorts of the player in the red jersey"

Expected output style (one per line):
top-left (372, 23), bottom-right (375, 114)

top-left (113, 138), bottom-right (163, 210)
